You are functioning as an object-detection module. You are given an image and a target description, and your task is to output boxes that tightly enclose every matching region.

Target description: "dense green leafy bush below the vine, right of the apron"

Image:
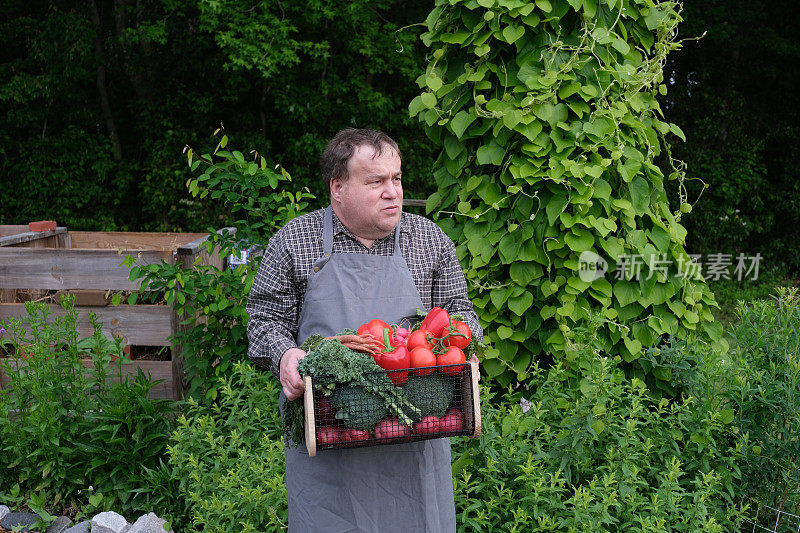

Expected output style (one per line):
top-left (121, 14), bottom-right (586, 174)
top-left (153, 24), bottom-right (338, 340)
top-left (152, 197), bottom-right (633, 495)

top-left (453, 314), bottom-right (740, 531)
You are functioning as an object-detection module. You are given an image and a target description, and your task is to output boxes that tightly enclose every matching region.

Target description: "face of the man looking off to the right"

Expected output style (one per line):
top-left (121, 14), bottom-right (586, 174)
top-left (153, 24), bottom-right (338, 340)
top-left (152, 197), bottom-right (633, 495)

top-left (331, 146), bottom-right (403, 247)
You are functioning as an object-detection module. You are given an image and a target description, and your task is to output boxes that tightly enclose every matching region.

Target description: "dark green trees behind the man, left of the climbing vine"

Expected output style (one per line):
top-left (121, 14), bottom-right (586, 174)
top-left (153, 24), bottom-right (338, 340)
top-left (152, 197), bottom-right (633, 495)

top-left (0, 0), bottom-right (433, 231)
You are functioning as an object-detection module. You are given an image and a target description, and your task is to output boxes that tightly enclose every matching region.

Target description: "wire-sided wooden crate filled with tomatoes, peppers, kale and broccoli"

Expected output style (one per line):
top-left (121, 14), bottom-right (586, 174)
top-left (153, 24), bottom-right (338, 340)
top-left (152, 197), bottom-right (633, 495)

top-left (284, 308), bottom-right (481, 456)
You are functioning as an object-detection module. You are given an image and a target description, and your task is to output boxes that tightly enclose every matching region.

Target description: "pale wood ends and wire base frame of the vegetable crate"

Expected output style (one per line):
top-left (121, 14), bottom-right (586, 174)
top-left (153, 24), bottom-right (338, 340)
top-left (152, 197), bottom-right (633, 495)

top-left (303, 361), bottom-right (481, 457)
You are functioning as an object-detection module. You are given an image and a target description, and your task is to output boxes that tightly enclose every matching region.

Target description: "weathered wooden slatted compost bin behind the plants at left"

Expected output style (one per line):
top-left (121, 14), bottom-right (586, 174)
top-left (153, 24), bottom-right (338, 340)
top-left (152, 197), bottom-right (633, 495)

top-left (0, 225), bottom-right (222, 399)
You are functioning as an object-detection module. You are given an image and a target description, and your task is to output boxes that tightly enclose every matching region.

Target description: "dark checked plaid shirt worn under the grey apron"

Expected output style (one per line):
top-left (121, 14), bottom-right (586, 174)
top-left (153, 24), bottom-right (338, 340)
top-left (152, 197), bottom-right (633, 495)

top-left (247, 209), bottom-right (483, 377)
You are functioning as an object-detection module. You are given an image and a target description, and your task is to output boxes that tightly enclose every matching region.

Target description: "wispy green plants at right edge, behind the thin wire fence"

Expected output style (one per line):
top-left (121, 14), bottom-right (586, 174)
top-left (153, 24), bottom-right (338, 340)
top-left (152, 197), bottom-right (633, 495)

top-left (728, 288), bottom-right (800, 515)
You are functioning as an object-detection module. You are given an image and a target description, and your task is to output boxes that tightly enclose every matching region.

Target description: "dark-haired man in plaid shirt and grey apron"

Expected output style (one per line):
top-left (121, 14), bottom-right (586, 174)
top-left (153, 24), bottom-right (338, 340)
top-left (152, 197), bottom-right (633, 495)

top-left (247, 129), bottom-right (482, 532)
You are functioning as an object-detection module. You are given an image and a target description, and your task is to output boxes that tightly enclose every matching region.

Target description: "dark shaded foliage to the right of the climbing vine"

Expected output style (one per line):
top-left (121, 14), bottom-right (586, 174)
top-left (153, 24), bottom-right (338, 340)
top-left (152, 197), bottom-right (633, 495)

top-left (664, 0), bottom-right (800, 275)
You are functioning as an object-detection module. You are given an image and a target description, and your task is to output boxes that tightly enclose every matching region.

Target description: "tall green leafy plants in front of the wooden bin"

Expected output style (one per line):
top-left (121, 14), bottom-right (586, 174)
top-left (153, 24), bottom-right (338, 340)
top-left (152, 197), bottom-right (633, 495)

top-left (0, 298), bottom-right (174, 514)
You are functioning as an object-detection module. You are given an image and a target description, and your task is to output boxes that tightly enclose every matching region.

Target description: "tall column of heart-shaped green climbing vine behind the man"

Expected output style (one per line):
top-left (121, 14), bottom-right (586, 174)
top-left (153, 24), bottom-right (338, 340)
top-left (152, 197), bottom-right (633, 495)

top-left (409, 0), bottom-right (725, 384)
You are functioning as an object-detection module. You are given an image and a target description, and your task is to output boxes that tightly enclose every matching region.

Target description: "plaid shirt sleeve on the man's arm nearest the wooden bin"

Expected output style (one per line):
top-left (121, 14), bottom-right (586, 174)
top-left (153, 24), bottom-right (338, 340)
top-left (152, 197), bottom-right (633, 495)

top-left (246, 232), bottom-right (300, 378)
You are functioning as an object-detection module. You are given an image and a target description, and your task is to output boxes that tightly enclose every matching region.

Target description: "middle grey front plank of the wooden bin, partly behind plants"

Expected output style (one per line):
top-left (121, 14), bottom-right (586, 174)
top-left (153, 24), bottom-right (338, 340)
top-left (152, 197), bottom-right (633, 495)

top-left (0, 304), bottom-right (172, 346)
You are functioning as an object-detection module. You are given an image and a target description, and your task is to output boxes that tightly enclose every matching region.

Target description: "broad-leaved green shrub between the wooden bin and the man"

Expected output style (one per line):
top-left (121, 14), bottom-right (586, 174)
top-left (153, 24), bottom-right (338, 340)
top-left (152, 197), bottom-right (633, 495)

top-left (130, 135), bottom-right (312, 400)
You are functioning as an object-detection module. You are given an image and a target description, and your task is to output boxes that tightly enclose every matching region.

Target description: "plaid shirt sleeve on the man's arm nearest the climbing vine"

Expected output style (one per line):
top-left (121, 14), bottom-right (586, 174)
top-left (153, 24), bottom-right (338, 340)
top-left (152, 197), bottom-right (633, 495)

top-left (431, 232), bottom-right (483, 340)
